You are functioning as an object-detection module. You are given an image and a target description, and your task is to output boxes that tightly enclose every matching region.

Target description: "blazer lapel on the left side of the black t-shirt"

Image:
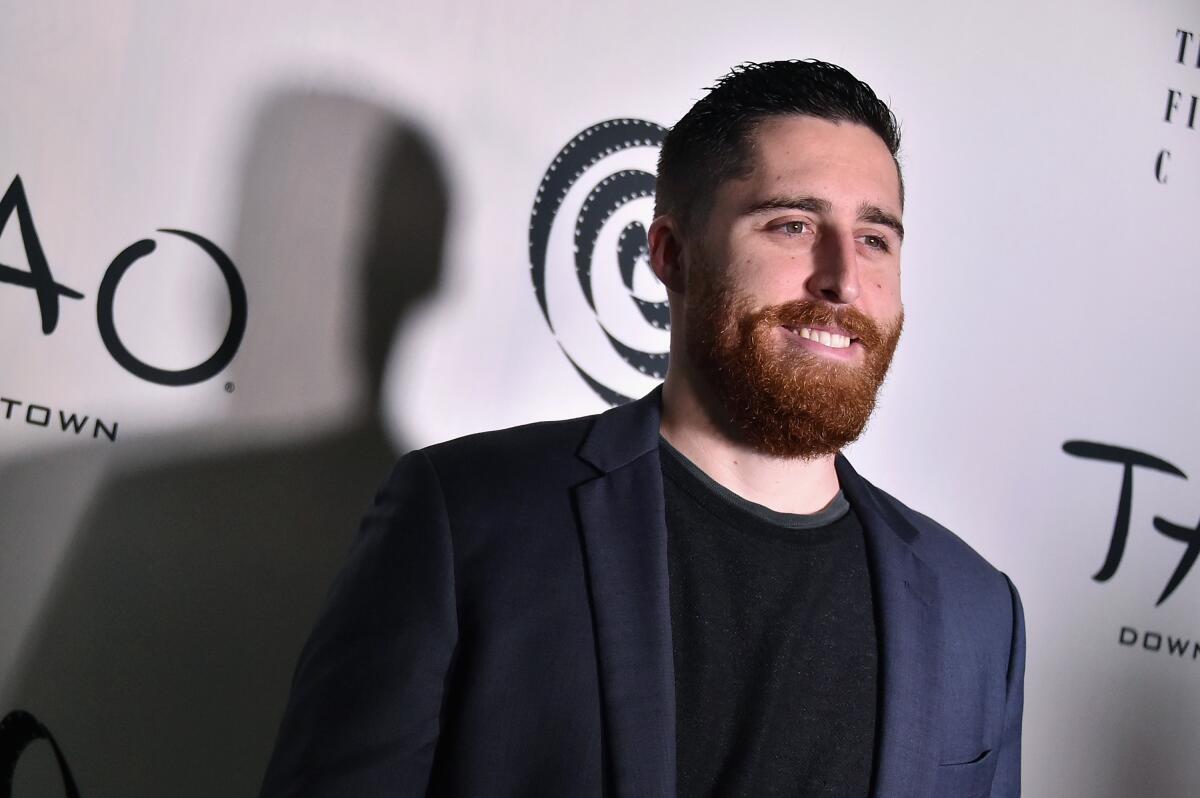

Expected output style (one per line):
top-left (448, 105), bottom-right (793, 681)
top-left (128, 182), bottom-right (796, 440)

top-left (575, 390), bottom-right (676, 797)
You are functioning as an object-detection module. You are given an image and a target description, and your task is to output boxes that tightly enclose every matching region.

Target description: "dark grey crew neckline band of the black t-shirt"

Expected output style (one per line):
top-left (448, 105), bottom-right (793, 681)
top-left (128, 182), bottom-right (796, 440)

top-left (659, 434), bottom-right (850, 542)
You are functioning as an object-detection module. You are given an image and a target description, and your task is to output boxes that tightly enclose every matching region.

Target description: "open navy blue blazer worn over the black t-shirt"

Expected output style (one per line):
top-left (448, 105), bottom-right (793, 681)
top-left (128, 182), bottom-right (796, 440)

top-left (262, 390), bottom-right (1025, 798)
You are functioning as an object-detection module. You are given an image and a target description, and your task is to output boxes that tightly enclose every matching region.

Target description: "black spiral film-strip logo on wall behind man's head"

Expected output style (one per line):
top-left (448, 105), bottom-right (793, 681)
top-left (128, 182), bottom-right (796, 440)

top-left (529, 119), bottom-right (671, 404)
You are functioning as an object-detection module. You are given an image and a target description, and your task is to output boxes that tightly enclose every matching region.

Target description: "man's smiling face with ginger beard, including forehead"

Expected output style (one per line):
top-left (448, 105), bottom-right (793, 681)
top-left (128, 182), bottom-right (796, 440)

top-left (684, 116), bottom-right (904, 458)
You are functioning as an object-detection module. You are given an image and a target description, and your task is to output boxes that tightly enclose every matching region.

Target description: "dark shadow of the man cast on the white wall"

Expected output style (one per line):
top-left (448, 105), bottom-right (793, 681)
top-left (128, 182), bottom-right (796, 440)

top-left (0, 91), bottom-right (448, 798)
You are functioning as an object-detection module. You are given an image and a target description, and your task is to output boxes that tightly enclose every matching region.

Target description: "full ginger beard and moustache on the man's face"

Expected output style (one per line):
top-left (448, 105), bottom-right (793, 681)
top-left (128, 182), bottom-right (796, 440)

top-left (685, 264), bottom-right (904, 460)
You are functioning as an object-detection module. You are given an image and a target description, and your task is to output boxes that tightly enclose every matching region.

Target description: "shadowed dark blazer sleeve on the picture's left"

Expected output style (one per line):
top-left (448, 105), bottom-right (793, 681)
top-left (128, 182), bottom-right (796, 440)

top-left (260, 451), bottom-right (458, 798)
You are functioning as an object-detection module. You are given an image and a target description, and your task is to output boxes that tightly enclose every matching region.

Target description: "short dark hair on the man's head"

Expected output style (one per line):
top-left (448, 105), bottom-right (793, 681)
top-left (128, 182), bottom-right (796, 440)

top-left (654, 59), bottom-right (904, 230)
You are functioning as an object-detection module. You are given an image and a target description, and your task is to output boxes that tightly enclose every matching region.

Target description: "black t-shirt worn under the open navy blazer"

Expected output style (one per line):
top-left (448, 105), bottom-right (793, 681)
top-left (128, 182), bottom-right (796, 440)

top-left (660, 439), bottom-right (878, 798)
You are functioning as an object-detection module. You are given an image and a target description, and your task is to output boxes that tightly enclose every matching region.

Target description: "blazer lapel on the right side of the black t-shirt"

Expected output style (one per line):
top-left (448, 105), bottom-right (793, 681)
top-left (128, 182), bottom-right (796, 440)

top-left (836, 455), bottom-right (942, 798)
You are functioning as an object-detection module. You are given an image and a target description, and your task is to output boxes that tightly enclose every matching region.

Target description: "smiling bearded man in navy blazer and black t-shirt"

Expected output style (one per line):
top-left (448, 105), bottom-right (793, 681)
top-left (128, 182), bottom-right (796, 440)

top-left (263, 61), bottom-right (1025, 798)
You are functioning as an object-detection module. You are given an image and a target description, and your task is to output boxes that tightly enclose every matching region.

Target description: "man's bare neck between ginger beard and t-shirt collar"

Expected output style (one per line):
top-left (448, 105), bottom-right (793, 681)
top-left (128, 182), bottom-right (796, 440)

top-left (660, 370), bottom-right (839, 514)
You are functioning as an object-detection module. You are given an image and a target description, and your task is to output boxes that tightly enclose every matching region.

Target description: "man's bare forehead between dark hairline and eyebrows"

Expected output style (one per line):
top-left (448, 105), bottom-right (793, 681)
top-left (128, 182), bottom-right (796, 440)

top-left (731, 115), bottom-right (901, 216)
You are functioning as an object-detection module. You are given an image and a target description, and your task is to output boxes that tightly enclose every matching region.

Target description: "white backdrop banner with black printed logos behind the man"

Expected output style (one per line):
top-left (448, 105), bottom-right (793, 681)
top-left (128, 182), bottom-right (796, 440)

top-left (0, 0), bottom-right (1200, 798)
